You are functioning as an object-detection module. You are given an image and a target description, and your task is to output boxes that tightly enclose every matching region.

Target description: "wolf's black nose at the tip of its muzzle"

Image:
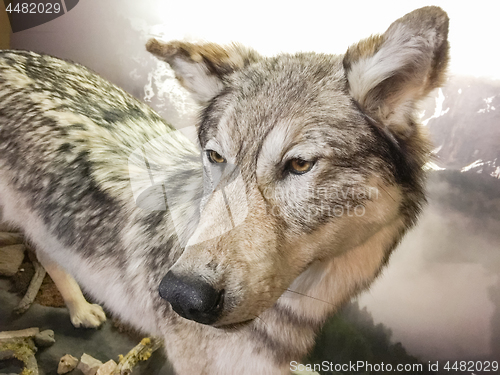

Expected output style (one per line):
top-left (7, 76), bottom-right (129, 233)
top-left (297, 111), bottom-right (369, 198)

top-left (159, 271), bottom-right (224, 324)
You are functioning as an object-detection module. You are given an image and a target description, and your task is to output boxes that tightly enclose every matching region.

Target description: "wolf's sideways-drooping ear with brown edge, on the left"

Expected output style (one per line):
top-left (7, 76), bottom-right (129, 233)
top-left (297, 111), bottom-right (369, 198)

top-left (146, 38), bottom-right (261, 104)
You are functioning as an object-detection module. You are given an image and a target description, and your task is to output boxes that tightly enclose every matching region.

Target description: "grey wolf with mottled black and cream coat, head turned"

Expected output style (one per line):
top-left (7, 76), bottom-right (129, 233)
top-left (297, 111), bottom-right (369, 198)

top-left (0, 7), bottom-right (448, 374)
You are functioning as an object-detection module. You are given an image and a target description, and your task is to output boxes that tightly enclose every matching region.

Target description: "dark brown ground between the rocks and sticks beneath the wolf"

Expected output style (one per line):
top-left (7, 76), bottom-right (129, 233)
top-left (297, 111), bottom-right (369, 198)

top-left (0, 244), bottom-right (173, 375)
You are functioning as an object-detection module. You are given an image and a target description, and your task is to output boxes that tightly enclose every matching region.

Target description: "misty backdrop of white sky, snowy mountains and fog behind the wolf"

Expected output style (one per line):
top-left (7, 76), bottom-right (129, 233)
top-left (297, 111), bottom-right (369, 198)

top-left (4, 0), bottom-right (500, 372)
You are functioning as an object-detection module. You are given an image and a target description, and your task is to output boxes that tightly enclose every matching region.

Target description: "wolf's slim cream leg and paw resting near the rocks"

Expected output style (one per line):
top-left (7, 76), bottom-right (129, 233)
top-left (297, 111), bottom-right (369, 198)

top-left (37, 251), bottom-right (106, 328)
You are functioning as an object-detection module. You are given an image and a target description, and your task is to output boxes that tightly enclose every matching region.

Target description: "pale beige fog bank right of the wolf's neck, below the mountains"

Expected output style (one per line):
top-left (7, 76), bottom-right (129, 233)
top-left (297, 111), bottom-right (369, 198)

top-left (360, 202), bottom-right (500, 360)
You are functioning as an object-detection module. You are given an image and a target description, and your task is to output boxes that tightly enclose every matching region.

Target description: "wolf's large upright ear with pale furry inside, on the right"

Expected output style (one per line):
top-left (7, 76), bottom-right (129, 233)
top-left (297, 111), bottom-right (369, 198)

top-left (343, 6), bottom-right (448, 140)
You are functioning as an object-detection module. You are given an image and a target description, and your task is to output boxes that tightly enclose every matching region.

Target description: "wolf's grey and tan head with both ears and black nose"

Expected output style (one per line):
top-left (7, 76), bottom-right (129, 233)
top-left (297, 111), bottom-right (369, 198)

top-left (147, 7), bottom-right (448, 326)
